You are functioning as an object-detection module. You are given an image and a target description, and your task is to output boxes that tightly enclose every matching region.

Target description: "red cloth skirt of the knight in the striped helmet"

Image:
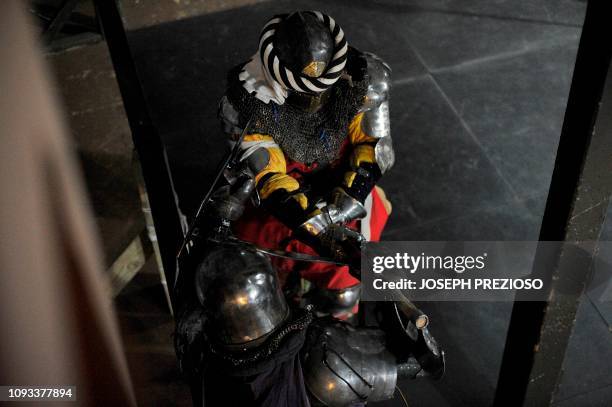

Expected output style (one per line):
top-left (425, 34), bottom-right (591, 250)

top-left (234, 189), bottom-right (389, 289)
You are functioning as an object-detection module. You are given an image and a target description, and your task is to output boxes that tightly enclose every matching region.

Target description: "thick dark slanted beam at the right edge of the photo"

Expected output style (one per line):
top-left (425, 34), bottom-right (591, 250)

top-left (494, 1), bottom-right (612, 406)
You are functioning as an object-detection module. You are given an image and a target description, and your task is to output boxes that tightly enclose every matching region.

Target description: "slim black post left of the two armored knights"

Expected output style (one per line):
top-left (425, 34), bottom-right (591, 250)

top-left (94, 0), bottom-right (183, 301)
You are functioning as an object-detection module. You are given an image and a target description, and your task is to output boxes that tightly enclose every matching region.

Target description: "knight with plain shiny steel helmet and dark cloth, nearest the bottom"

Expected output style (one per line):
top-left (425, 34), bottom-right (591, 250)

top-left (175, 233), bottom-right (444, 407)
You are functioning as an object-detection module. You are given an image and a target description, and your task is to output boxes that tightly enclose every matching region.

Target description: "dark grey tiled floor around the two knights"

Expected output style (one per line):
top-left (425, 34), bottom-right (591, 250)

top-left (120, 0), bottom-right (612, 406)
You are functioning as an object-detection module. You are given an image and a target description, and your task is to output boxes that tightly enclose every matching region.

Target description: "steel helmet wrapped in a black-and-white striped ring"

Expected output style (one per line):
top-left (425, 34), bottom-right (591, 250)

top-left (259, 11), bottom-right (348, 93)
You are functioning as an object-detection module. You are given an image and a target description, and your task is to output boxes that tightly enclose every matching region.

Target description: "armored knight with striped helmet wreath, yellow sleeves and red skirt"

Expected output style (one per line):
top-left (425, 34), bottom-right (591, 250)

top-left (219, 11), bottom-right (394, 316)
